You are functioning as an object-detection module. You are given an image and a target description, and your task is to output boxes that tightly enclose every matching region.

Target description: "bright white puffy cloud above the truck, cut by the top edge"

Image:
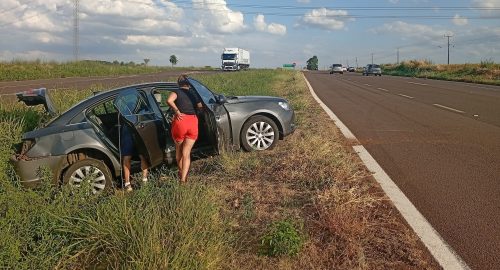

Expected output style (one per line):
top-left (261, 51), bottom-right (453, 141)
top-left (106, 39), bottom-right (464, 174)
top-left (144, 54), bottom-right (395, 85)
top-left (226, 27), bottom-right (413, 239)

top-left (193, 0), bottom-right (246, 33)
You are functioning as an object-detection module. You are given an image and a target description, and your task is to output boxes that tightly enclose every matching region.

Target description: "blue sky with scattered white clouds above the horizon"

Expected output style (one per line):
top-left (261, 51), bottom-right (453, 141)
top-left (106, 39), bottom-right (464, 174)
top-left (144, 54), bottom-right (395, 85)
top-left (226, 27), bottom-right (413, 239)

top-left (0, 0), bottom-right (500, 68)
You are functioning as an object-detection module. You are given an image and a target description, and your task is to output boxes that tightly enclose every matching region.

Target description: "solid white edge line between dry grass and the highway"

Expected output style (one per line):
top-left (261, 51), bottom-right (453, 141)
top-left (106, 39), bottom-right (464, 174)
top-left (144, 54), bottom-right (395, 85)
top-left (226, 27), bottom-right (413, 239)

top-left (302, 74), bottom-right (470, 270)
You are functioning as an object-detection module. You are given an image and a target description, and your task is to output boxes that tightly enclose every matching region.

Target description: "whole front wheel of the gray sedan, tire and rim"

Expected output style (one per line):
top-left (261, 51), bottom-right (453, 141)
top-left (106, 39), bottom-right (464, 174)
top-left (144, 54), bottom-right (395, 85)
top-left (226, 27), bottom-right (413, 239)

top-left (240, 115), bottom-right (279, 152)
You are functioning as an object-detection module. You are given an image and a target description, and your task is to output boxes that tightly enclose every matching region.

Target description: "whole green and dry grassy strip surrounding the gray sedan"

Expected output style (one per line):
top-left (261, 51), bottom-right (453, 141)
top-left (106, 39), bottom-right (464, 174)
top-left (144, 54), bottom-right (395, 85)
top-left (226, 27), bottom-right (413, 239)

top-left (0, 70), bottom-right (439, 269)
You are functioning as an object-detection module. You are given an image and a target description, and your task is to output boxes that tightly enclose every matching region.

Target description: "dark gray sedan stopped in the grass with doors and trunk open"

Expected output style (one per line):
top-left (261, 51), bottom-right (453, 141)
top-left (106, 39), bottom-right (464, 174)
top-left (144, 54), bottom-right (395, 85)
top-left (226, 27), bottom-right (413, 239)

top-left (10, 78), bottom-right (295, 193)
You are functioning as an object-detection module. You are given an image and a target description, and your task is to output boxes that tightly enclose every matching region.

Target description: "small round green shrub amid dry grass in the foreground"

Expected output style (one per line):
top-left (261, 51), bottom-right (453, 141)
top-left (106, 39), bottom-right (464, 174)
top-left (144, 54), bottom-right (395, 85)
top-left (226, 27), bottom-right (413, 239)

top-left (261, 220), bottom-right (304, 257)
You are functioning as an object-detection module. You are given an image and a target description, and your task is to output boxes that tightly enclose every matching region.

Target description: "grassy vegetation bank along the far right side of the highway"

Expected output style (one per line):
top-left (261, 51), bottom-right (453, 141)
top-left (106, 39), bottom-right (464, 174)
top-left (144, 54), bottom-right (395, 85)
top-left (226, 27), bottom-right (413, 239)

top-left (382, 60), bottom-right (500, 85)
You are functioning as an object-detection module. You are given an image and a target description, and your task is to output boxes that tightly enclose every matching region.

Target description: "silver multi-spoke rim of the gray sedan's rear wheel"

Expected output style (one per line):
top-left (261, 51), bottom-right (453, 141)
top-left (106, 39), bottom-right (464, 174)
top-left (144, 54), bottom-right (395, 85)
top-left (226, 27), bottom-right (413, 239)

top-left (69, 166), bottom-right (106, 194)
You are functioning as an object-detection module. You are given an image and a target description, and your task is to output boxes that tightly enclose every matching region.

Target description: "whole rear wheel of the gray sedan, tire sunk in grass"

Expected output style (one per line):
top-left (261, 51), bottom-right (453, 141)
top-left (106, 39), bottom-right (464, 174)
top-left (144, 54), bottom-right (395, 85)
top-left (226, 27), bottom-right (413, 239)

top-left (63, 158), bottom-right (112, 194)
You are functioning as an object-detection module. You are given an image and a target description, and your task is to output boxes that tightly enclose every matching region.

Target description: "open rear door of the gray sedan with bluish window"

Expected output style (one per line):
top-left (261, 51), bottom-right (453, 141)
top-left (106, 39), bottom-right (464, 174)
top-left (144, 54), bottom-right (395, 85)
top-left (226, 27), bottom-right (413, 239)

top-left (114, 88), bottom-right (164, 167)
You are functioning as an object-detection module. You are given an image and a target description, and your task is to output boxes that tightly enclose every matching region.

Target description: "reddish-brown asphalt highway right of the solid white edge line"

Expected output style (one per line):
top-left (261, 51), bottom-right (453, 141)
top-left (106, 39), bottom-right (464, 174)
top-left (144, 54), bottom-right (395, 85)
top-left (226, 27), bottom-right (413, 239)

top-left (305, 72), bottom-right (500, 269)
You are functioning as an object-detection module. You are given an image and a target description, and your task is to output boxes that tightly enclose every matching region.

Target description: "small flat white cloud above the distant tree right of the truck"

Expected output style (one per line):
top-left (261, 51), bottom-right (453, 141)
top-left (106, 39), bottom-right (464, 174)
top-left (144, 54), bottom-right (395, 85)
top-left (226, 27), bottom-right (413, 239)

top-left (301, 8), bottom-right (354, 30)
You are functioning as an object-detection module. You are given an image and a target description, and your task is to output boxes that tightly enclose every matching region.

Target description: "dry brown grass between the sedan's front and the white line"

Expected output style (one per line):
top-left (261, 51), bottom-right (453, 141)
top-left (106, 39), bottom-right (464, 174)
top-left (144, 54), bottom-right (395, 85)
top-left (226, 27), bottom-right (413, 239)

top-left (189, 70), bottom-right (439, 269)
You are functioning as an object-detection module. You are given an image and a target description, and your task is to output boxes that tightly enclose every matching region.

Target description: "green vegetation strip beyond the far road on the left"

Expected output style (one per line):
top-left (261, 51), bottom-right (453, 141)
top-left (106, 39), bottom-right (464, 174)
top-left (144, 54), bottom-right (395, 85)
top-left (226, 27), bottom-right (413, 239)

top-left (0, 59), bottom-right (205, 81)
